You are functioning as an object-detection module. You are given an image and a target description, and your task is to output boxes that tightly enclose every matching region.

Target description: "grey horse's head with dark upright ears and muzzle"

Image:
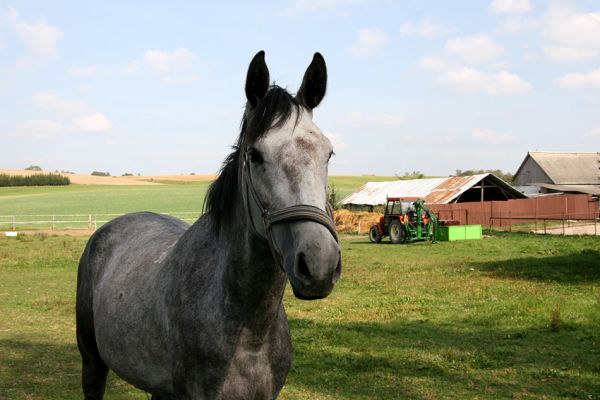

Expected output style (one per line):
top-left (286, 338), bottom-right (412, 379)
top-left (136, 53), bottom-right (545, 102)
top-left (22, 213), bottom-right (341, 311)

top-left (239, 51), bottom-right (342, 299)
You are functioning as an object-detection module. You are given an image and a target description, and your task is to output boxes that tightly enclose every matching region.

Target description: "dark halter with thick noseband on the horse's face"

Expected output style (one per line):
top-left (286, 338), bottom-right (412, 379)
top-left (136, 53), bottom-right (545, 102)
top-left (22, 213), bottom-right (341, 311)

top-left (242, 148), bottom-right (339, 272)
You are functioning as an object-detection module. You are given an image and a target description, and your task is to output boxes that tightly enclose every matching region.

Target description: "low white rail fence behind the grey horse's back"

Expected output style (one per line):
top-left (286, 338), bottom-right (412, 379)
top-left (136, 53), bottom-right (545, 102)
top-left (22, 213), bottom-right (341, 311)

top-left (0, 211), bottom-right (202, 231)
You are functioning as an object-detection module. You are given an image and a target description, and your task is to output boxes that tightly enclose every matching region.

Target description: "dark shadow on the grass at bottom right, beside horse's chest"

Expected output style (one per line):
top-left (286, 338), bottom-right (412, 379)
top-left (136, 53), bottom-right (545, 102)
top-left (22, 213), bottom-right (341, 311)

top-left (288, 319), bottom-right (600, 399)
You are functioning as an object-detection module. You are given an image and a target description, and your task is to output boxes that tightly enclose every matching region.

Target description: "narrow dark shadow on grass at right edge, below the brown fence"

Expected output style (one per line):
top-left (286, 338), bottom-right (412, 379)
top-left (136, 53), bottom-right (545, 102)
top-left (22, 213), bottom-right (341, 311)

top-left (470, 249), bottom-right (600, 284)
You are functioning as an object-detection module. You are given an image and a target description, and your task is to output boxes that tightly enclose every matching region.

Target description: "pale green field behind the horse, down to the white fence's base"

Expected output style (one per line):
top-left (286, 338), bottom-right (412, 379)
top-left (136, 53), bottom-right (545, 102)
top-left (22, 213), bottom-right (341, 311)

top-left (0, 176), bottom-right (396, 230)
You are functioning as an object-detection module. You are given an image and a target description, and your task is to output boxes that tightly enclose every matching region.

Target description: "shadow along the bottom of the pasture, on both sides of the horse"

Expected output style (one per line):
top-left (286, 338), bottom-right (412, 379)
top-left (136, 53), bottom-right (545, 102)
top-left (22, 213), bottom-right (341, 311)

top-left (0, 319), bottom-right (600, 399)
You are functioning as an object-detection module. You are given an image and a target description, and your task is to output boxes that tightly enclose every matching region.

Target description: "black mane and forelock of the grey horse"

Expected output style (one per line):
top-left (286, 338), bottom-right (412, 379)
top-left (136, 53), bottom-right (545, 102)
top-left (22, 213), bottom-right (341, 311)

top-left (204, 85), bottom-right (303, 232)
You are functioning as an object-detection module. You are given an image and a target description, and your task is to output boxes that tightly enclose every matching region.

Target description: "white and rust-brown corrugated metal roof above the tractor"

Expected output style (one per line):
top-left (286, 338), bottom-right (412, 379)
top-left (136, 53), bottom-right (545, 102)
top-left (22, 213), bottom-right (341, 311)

top-left (342, 174), bottom-right (525, 206)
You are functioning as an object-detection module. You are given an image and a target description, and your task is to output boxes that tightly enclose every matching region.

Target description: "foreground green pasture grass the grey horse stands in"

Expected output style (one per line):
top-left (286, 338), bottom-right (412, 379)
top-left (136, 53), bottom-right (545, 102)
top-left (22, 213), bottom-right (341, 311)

top-left (0, 234), bottom-right (600, 400)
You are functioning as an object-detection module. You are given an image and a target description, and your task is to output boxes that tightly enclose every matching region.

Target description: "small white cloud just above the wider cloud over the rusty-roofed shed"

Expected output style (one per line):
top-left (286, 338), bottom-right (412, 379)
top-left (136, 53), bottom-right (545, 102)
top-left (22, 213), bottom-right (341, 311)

top-left (446, 34), bottom-right (504, 64)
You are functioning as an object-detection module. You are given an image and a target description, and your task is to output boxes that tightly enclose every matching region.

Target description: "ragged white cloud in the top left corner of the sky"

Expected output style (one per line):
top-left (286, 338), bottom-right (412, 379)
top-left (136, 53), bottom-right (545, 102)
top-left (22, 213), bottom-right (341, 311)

top-left (6, 8), bottom-right (62, 58)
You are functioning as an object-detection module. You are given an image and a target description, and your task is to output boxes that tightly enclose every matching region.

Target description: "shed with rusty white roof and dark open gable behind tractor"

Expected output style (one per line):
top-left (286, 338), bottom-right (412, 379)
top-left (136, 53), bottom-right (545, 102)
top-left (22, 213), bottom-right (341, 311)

top-left (341, 174), bottom-right (526, 208)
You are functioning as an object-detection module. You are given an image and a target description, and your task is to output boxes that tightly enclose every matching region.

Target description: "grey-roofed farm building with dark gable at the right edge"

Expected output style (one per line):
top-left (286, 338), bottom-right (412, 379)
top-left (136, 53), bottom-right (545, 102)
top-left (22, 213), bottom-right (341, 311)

top-left (514, 151), bottom-right (600, 195)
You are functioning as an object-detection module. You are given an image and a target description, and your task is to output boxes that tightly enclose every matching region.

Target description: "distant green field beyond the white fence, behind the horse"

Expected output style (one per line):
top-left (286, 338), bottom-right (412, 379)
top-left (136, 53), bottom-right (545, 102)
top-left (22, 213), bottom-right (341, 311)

top-left (0, 176), bottom-right (394, 228)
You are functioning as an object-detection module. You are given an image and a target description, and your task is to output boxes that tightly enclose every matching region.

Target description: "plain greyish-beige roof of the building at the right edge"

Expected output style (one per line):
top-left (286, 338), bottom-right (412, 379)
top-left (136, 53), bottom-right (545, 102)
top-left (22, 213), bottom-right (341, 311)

top-left (517, 151), bottom-right (600, 185)
